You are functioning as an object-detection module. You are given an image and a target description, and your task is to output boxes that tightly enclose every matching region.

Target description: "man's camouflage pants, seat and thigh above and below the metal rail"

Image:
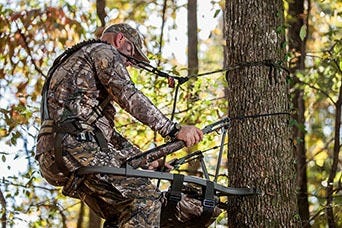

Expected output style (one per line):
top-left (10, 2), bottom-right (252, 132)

top-left (38, 135), bottom-right (161, 227)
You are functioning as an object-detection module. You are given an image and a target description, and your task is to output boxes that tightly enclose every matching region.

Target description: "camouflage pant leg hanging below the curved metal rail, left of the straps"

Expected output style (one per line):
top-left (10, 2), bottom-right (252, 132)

top-left (72, 175), bottom-right (161, 227)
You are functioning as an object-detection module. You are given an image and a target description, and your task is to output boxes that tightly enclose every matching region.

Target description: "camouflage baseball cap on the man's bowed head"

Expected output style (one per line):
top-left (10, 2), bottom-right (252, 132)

top-left (103, 23), bottom-right (150, 62)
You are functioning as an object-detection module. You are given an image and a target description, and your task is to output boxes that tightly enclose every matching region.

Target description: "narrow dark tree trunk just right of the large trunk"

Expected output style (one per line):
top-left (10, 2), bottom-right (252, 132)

top-left (288, 0), bottom-right (310, 227)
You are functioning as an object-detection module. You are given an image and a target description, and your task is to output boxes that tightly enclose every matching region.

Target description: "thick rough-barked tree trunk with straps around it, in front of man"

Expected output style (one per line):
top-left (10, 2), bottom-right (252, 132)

top-left (225, 0), bottom-right (296, 227)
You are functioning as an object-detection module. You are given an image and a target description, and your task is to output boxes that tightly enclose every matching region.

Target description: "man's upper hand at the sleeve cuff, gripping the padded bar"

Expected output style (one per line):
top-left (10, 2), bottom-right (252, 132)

top-left (176, 125), bottom-right (203, 147)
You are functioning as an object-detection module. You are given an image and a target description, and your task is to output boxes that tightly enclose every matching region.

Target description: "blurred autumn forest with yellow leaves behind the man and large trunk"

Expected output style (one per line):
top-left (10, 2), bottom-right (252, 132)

top-left (0, 0), bottom-right (342, 227)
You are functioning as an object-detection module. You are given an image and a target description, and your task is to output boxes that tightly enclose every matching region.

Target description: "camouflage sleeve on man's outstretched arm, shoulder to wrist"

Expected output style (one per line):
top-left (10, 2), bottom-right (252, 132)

top-left (92, 45), bottom-right (174, 137)
